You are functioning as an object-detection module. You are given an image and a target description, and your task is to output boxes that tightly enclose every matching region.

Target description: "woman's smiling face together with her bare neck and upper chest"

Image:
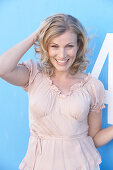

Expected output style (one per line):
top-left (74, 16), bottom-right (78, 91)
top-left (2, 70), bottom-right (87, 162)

top-left (48, 30), bottom-right (86, 93)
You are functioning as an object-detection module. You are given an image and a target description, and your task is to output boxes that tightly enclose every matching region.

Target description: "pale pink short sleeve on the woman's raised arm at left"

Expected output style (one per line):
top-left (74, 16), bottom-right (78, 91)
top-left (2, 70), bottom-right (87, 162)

top-left (18, 59), bottom-right (40, 91)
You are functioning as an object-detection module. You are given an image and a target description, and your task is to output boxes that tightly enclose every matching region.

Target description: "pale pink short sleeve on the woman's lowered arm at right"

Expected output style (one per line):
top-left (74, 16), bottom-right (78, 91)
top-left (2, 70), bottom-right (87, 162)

top-left (90, 77), bottom-right (105, 112)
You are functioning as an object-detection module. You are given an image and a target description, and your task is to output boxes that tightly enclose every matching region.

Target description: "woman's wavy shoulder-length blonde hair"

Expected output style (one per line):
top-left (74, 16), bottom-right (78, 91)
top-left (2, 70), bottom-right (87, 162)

top-left (34, 14), bottom-right (89, 76)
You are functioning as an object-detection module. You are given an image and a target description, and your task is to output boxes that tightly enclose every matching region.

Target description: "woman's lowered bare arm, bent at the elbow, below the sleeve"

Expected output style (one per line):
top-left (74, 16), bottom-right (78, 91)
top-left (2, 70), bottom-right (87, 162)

top-left (88, 111), bottom-right (113, 147)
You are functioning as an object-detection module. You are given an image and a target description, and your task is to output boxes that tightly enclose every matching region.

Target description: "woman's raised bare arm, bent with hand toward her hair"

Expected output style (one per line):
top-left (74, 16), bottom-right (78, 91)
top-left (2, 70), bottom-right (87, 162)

top-left (0, 31), bottom-right (37, 86)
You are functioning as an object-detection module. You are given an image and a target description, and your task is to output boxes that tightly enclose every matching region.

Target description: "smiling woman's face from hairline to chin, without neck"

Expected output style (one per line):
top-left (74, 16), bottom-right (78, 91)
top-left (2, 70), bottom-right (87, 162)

top-left (48, 31), bottom-right (78, 72)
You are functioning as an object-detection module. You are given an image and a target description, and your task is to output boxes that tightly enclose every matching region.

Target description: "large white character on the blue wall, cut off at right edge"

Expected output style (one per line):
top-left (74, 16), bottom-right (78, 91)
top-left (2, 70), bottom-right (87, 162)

top-left (91, 33), bottom-right (113, 124)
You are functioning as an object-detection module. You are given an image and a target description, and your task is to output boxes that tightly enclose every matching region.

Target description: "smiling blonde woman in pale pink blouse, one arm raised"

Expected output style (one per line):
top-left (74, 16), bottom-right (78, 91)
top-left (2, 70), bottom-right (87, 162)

top-left (0, 14), bottom-right (113, 170)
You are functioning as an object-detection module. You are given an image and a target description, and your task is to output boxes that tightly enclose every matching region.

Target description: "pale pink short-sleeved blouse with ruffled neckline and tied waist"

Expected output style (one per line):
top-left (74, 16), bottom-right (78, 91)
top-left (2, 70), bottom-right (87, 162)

top-left (19, 60), bottom-right (105, 170)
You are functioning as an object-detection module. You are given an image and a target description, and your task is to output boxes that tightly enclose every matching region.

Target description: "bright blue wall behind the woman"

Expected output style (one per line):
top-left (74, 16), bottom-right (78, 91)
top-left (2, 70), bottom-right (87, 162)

top-left (0, 0), bottom-right (113, 170)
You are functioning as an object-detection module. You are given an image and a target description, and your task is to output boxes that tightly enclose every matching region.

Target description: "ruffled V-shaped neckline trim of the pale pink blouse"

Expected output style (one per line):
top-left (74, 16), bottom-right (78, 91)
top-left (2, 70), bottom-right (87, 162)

top-left (46, 73), bottom-right (91, 98)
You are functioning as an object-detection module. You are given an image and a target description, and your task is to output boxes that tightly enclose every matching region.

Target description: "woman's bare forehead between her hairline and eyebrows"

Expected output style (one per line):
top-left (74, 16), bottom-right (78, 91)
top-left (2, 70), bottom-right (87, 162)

top-left (50, 31), bottom-right (77, 43)
